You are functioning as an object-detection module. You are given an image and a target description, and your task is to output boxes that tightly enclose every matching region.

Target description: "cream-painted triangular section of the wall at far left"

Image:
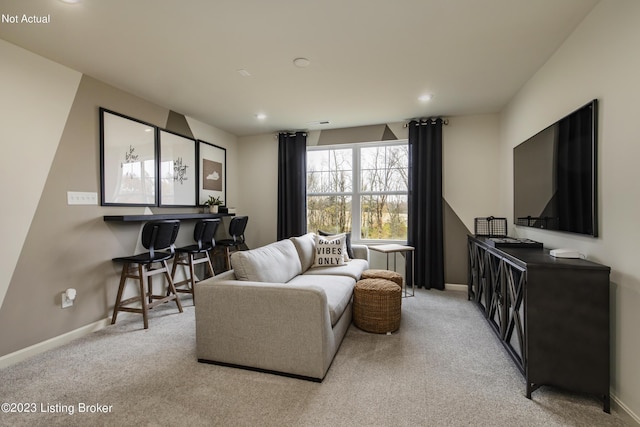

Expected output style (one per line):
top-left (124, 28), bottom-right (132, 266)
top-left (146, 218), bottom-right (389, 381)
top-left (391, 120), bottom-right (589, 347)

top-left (0, 40), bottom-right (82, 307)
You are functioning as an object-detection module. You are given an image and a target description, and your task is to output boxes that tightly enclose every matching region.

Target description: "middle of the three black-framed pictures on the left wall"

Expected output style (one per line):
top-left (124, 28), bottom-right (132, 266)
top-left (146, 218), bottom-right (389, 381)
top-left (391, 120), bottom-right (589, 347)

top-left (158, 129), bottom-right (198, 206)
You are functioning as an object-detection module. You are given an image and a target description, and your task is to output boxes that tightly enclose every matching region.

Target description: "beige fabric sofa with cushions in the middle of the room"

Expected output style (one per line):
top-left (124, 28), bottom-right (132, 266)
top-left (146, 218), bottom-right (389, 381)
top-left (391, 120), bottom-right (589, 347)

top-left (195, 233), bottom-right (369, 381)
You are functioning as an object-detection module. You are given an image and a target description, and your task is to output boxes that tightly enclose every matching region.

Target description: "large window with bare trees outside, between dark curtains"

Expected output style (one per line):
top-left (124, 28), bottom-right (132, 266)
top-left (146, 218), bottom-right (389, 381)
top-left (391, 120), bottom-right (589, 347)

top-left (307, 141), bottom-right (409, 241)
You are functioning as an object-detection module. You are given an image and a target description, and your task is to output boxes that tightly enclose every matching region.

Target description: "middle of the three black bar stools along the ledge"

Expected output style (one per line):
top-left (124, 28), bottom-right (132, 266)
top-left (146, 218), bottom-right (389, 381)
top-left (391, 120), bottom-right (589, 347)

top-left (171, 219), bottom-right (220, 305)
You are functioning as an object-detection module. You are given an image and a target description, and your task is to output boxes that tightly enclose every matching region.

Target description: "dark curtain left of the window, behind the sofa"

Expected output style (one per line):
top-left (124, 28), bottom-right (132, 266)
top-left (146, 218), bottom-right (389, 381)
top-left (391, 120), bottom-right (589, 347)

top-left (277, 132), bottom-right (307, 240)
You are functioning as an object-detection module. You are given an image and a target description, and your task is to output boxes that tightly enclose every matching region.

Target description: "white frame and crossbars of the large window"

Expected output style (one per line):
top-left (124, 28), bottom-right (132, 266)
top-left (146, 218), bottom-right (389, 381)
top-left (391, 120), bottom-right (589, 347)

top-left (305, 139), bottom-right (409, 244)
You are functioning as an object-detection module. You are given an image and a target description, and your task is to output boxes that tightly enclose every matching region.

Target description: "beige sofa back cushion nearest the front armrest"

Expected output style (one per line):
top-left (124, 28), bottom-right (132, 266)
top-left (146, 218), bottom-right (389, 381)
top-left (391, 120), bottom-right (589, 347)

top-left (231, 239), bottom-right (302, 283)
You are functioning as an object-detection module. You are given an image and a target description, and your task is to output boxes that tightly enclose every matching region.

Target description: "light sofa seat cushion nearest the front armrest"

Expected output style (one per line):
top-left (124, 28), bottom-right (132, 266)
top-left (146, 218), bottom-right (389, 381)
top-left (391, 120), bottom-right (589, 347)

top-left (288, 275), bottom-right (356, 326)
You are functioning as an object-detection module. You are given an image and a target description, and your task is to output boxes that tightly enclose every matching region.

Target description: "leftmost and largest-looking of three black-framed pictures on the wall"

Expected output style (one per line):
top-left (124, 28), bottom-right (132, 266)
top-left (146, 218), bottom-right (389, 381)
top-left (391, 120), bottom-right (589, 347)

top-left (100, 108), bottom-right (158, 206)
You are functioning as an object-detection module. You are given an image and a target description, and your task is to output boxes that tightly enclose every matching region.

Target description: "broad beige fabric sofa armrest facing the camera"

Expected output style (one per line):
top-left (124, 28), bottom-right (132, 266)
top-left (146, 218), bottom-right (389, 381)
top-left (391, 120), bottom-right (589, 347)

top-left (195, 280), bottom-right (339, 380)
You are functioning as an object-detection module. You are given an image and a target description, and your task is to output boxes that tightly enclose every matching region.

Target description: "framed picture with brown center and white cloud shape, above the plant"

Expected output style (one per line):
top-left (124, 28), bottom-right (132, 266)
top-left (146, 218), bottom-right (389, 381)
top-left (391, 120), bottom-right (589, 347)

top-left (198, 141), bottom-right (227, 205)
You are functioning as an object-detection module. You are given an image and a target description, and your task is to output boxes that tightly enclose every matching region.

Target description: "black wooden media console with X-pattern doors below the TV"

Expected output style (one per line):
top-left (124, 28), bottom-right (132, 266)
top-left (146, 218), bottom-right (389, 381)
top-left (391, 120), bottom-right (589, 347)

top-left (468, 236), bottom-right (610, 413)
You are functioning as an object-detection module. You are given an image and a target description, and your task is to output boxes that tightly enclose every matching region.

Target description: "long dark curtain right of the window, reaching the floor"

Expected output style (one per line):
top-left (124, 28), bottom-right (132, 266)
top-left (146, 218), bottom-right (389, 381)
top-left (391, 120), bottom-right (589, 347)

top-left (406, 118), bottom-right (444, 289)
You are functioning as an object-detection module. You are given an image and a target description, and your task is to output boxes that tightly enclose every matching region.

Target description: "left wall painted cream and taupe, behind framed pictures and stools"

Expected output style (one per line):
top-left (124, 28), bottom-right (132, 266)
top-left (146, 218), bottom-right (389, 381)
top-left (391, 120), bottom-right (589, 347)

top-left (0, 41), bottom-right (237, 356)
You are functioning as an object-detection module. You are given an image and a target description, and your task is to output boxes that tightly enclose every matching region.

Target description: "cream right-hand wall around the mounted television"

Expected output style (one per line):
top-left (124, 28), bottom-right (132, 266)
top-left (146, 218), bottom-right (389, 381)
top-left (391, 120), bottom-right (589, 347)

top-left (501, 0), bottom-right (640, 422)
